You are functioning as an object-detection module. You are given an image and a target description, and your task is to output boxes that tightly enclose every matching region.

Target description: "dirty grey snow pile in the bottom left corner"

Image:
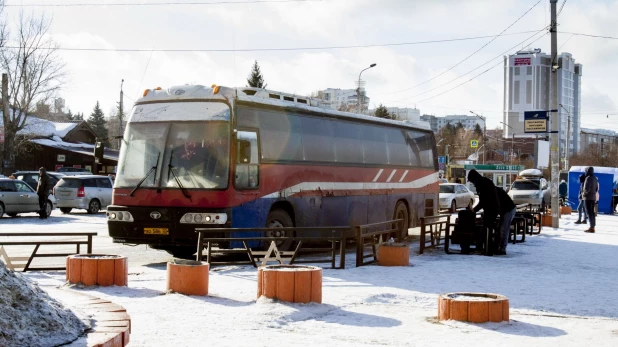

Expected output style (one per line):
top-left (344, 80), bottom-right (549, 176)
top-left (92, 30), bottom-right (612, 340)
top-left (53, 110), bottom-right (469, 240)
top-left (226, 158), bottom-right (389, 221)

top-left (0, 261), bottom-right (87, 347)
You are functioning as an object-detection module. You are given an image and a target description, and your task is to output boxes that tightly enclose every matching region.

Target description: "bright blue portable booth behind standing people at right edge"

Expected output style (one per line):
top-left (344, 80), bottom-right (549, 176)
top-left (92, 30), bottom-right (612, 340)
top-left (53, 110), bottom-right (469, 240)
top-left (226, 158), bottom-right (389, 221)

top-left (568, 166), bottom-right (618, 214)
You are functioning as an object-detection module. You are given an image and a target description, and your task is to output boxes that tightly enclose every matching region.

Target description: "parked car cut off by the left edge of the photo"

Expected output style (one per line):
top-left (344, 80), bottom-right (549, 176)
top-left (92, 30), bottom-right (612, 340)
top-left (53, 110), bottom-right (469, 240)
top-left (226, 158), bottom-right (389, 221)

top-left (0, 178), bottom-right (54, 217)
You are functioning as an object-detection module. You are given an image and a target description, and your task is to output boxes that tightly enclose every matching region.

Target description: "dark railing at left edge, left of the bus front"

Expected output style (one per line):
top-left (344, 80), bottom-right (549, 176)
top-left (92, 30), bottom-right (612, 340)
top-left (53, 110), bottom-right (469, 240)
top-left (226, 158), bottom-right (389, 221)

top-left (0, 232), bottom-right (97, 272)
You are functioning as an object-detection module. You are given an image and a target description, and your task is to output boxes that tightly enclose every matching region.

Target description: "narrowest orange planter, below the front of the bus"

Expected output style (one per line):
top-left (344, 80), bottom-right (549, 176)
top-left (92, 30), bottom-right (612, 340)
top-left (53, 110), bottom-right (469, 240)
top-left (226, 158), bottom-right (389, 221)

top-left (166, 259), bottom-right (210, 296)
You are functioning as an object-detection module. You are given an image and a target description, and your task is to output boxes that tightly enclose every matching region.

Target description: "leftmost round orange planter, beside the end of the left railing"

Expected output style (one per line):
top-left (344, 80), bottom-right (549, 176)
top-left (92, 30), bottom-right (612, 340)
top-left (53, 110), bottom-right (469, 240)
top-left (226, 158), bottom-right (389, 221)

top-left (66, 254), bottom-right (129, 286)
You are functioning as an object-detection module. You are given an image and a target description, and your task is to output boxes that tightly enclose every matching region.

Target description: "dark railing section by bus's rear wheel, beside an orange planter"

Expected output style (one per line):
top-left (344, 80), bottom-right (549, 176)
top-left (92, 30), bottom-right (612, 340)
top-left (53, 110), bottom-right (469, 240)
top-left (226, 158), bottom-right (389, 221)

top-left (356, 219), bottom-right (403, 267)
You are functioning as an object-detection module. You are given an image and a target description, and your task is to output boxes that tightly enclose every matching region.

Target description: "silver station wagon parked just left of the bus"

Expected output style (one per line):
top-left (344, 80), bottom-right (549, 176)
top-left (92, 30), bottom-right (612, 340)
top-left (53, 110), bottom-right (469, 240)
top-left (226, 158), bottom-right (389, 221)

top-left (54, 175), bottom-right (113, 213)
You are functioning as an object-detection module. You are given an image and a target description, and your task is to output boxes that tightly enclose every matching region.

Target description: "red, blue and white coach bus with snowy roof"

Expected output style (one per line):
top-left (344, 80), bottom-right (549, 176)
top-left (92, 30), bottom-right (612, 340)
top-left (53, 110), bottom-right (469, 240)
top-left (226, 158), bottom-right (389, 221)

top-left (107, 85), bottom-right (438, 257)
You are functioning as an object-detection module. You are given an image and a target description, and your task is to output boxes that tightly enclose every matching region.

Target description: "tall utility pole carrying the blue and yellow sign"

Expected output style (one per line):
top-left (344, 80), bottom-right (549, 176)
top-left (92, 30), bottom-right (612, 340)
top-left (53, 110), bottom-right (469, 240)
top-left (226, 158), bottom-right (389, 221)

top-left (549, 0), bottom-right (560, 228)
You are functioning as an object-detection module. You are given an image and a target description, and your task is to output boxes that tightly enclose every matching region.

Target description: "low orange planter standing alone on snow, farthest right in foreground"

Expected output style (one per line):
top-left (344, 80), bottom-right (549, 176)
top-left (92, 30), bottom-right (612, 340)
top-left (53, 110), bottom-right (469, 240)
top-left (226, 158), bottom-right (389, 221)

top-left (438, 293), bottom-right (509, 323)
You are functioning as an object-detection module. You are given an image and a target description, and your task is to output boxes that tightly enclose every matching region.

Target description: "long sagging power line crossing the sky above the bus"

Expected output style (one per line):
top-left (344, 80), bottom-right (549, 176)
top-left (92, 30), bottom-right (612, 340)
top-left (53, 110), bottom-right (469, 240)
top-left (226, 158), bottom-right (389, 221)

top-left (4, 30), bottom-right (548, 52)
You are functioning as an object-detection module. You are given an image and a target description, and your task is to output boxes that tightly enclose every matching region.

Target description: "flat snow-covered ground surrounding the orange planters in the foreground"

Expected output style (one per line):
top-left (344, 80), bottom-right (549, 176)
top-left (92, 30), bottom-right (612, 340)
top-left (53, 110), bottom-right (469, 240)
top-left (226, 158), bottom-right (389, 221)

top-left (19, 215), bottom-right (618, 347)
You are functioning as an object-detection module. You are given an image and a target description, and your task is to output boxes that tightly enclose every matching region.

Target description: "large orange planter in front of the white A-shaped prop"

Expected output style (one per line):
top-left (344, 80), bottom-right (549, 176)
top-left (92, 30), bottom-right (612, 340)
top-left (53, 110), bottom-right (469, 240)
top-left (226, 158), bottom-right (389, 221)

top-left (257, 265), bottom-right (322, 304)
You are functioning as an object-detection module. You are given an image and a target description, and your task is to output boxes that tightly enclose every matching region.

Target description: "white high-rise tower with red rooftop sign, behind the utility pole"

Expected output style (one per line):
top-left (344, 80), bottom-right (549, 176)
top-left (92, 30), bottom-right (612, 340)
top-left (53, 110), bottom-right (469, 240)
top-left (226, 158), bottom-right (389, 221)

top-left (503, 49), bottom-right (582, 156)
